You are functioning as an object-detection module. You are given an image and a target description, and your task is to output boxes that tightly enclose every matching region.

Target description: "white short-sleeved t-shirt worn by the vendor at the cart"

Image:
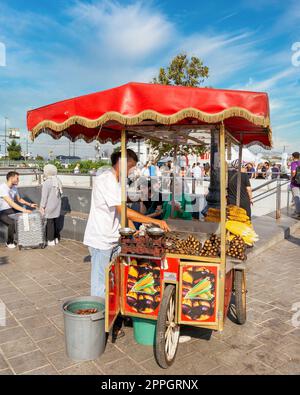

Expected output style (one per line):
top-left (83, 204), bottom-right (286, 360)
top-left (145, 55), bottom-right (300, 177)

top-left (83, 169), bottom-right (121, 250)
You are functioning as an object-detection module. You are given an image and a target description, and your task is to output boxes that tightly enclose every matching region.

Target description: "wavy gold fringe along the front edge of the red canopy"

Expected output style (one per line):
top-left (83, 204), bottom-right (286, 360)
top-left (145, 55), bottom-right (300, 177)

top-left (32, 107), bottom-right (270, 138)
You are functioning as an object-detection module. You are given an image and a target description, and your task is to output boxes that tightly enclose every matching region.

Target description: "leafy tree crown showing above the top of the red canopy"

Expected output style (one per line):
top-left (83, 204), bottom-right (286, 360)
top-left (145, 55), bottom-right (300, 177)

top-left (152, 53), bottom-right (209, 86)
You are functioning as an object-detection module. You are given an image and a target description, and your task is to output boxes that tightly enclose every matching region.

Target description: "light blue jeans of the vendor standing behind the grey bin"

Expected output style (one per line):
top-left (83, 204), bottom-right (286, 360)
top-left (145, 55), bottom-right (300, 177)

top-left (89, 246), bottom-right (119, 298)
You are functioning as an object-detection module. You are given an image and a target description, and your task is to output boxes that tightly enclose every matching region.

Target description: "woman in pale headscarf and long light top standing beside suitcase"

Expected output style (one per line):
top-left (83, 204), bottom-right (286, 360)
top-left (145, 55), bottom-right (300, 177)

top-left (40, 164), bottom-right (62, 246)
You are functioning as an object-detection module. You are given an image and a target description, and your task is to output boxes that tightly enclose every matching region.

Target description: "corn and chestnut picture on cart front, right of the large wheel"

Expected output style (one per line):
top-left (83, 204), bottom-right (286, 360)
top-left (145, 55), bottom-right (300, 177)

top-left (182, 267), bottom-right (215, 321)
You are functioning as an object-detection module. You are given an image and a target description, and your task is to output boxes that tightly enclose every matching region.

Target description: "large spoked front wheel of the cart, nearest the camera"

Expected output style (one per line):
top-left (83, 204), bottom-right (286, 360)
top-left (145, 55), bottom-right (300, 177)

top-left (154, 285), bottom-right (180, 369)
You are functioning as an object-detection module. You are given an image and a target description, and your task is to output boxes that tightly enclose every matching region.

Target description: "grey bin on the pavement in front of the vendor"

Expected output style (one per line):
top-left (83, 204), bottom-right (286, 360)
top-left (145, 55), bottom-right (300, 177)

top-left (62, 296), bottom-right (106, 361)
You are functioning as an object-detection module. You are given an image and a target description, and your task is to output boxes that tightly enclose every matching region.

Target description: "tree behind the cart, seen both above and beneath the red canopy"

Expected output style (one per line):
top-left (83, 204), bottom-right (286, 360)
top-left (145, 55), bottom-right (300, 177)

top-left (147, 53), bottom-right (209, 161)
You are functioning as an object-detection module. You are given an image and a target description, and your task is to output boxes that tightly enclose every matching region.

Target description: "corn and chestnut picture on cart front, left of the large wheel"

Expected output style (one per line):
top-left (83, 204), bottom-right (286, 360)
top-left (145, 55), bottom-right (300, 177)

top-left (126, 264), bottom-right (160, 314)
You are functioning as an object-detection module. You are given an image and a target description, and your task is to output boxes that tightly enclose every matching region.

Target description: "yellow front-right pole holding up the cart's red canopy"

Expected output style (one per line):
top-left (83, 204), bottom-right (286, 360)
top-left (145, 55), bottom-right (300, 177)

top-left (218, 123), bottom-right (227, 331)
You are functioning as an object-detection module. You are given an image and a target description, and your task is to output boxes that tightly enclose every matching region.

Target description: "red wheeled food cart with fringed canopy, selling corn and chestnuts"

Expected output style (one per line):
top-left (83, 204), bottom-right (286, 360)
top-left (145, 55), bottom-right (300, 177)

top-left (27, 83), bottom-right (272, 368)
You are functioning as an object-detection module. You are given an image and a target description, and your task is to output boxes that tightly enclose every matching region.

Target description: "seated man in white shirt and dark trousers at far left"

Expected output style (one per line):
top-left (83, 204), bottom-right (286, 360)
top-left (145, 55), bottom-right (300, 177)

top-left (0, 171), bottom-right (37, 248)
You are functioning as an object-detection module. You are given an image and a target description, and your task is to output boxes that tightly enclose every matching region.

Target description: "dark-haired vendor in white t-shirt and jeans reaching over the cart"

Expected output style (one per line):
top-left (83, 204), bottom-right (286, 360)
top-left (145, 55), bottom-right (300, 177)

top-left (83, 149), bottom-right (169, 298)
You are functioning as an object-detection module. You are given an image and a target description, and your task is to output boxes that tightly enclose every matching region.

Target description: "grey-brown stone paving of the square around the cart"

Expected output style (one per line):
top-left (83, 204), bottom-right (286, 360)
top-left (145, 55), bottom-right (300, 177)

top-left (0, 231), bottom-right (300, 375)
